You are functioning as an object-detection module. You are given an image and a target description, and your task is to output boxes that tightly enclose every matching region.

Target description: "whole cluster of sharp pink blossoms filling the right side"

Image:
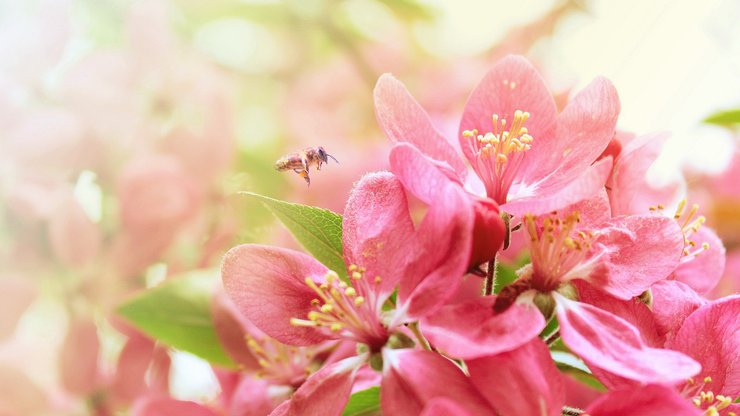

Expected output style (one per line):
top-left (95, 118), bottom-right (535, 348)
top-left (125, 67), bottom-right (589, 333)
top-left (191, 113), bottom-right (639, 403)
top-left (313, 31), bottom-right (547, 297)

top-left (218, 56), bottom-right (740, 416)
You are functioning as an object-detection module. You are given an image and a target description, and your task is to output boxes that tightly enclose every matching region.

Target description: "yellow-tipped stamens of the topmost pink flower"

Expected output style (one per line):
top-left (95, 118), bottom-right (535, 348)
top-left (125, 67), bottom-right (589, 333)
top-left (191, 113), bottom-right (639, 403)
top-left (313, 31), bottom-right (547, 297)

top-left (463, 110), bottom-right (534, 204)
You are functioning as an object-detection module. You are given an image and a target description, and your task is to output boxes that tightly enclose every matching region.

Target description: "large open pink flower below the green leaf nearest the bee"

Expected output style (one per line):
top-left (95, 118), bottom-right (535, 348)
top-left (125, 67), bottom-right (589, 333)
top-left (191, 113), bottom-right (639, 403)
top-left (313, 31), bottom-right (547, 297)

top-left (222, 173), bottom-right (473, 414)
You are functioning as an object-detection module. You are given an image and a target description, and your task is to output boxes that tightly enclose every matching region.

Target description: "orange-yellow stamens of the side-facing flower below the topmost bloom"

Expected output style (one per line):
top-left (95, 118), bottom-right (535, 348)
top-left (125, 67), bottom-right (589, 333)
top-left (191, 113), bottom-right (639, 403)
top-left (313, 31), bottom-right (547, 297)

top-left (524, 212), bottom-right (594, 292)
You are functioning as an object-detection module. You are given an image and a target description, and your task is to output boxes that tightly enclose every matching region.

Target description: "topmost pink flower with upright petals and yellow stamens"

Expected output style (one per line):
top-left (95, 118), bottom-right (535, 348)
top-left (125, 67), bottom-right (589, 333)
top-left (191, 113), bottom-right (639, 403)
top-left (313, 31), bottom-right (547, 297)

top-left (375, 56), bottom-right (619, 218)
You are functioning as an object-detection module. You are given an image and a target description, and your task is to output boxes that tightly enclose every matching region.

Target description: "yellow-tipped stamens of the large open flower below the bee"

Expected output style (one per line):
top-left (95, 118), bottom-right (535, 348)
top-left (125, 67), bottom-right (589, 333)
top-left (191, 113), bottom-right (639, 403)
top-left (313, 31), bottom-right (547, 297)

top-left (291, 264), bottom-right (388, 350)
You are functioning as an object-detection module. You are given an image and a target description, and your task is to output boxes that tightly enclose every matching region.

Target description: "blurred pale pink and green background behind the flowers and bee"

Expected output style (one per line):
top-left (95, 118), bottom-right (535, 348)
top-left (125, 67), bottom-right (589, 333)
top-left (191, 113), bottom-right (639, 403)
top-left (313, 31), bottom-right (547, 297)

top-left (0, 0), bottom-right (740, 415)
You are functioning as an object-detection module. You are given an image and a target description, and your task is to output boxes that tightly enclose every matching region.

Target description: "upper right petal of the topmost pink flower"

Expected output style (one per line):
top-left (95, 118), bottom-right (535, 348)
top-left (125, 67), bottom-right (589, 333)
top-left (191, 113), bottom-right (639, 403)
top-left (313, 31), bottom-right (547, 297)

top-left (523, 78), bottom-right (619, 187)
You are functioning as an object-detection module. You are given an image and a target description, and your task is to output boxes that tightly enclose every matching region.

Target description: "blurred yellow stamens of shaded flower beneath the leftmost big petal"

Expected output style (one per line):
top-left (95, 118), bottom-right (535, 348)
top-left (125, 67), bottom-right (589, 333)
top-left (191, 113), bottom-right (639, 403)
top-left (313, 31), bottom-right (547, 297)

top-left (246, 335), bottom-right (316, 387)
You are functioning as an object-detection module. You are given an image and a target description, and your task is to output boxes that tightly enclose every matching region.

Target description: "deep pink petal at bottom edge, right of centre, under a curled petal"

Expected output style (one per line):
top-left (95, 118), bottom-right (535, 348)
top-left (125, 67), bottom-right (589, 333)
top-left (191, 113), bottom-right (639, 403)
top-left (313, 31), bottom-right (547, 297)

top-left (467, 338), bottom-right (565, 416)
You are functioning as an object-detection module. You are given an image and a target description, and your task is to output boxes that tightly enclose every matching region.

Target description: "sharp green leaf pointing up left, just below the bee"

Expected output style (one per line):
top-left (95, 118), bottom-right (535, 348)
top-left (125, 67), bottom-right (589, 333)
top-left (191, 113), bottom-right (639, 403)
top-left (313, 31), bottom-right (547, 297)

top-left (241, 192), bottom-right (347, 278)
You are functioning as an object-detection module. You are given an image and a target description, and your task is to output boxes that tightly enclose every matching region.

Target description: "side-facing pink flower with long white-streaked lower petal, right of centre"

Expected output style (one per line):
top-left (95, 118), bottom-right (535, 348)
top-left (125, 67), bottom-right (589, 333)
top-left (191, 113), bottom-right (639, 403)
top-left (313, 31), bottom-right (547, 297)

top-left (480, 195), bottom-right (699, 384)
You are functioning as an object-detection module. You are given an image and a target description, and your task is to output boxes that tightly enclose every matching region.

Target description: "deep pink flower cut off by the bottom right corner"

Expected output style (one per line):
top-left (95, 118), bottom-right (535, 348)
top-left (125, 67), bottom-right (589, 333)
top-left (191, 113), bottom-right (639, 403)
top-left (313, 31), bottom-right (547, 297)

top-left (581, 280), bottom-right (740, 414)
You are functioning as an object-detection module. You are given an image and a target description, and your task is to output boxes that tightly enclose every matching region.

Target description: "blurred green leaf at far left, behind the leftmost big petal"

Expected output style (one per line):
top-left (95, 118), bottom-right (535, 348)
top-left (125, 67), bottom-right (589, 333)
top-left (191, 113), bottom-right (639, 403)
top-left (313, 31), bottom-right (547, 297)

top-left (118, 270), bottom-right (236, 368)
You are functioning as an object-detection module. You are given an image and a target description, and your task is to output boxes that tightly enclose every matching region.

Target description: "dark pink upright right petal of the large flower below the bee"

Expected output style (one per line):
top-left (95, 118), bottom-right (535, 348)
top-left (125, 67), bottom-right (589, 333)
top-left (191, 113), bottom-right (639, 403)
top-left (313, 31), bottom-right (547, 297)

top-left (392, 185), bottom-right (473, 325)
